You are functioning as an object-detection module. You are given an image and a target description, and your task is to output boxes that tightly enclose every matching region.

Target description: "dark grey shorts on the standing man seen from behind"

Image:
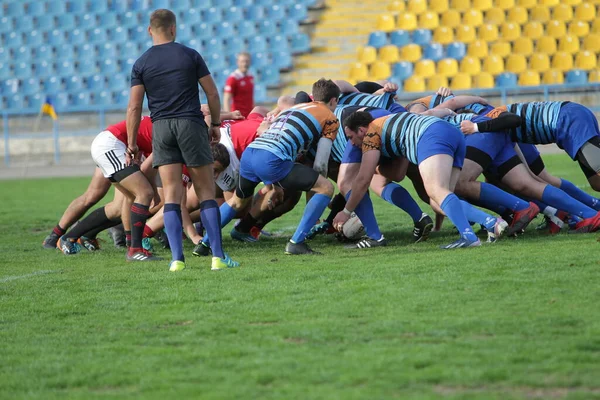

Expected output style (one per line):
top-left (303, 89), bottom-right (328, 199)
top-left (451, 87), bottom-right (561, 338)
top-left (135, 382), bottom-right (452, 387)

top-left (152, 118), bottom-right (213, 168)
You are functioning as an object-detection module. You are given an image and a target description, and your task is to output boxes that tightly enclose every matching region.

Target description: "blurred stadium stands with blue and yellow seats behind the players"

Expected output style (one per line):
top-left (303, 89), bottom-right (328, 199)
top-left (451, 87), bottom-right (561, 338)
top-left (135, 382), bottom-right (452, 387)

top-left (0, 0), bottom-right (600, 169)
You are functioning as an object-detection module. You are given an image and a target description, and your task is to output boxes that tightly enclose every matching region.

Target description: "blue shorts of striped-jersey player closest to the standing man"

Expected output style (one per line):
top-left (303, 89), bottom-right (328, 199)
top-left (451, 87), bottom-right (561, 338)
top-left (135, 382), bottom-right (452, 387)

top-left (240, 147), bottom-right (294, 185)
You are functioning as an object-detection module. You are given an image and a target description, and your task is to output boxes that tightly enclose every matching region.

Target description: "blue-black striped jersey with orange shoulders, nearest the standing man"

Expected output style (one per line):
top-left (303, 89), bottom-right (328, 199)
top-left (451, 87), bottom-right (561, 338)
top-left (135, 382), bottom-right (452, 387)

top-left (248, 102), bottom-right (340, 161)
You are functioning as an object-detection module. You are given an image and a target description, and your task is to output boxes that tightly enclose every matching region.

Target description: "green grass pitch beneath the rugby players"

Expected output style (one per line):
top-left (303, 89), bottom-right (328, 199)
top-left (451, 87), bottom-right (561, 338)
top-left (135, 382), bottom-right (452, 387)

top-left (0, 156), bottom-right (600, 399)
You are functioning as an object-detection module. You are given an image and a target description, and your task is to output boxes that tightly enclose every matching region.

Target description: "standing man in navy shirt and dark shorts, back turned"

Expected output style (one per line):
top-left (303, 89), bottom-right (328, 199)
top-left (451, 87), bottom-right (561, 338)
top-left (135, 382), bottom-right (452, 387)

top-left (127, 9), bottom-right (239, 271)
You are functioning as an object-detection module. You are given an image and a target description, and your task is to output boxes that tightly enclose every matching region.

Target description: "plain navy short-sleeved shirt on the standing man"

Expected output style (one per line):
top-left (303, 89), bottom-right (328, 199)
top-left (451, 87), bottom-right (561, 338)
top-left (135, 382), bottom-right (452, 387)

top-left (131, 42), bottom-right (210, 123)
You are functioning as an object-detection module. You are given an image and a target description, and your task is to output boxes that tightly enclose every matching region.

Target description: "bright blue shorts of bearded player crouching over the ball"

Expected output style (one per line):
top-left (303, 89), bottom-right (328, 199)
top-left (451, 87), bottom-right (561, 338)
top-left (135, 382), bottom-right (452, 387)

top-left (417, 121), bottom-right (467, 168)
